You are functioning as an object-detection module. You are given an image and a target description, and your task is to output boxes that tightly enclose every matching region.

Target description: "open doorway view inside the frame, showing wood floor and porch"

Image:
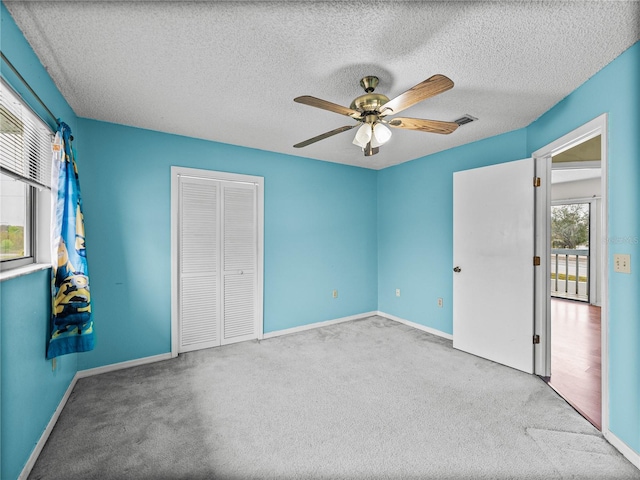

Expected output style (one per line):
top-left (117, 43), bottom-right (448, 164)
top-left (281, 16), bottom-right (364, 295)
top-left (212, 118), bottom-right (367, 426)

top-left (548, 135), bottom-right (602, 429)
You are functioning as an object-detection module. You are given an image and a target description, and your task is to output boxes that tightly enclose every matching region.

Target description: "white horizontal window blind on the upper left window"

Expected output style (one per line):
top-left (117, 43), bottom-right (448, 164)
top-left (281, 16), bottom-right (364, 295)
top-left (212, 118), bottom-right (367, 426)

top-left (0, 81), bottom-right (53, 188)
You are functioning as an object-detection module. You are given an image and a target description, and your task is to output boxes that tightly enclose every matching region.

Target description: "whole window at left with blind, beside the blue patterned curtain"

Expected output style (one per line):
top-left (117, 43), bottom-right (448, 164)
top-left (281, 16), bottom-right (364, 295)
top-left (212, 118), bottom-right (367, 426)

top-left (0, 81), bottom-right (53, 271)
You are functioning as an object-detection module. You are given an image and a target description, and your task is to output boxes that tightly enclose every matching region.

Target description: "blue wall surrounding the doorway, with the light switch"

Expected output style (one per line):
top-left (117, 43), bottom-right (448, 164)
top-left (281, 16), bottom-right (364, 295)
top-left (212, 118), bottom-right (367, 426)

top-left (527, 43), bottom-right (640, 452)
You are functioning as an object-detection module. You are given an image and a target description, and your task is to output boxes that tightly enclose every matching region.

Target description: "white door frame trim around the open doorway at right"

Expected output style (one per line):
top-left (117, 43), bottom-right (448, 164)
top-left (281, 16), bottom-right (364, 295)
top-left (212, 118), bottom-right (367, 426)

top-left (533, 113), bottom-right (609, 433)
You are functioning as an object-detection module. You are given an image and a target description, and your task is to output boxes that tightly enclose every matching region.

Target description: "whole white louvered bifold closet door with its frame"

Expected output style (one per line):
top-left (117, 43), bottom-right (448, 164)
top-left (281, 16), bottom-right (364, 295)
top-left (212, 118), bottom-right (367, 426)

top-left (172, 167), bottom-right (262, 354)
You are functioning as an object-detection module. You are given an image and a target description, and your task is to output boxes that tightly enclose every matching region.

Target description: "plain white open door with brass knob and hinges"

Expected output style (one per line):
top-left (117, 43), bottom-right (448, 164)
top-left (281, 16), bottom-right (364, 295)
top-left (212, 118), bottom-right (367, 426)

top-left (453, 159), bottom-right (534, 373)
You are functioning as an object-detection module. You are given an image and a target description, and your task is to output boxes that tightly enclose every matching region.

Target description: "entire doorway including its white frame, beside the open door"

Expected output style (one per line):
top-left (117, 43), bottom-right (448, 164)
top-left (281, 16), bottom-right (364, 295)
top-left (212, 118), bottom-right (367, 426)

top-left (534, 114), bottom-right (608, 432)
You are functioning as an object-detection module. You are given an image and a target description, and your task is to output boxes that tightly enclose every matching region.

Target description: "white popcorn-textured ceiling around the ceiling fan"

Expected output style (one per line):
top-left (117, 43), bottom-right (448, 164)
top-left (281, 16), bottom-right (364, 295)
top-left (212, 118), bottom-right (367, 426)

top-left (4, 0), bottom-right (640, 169)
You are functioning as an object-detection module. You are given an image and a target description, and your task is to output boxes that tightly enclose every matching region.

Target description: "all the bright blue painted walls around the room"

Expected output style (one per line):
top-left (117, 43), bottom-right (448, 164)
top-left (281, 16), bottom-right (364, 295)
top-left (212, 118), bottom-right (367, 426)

top-left (0, 0), bottom-right (640, 479)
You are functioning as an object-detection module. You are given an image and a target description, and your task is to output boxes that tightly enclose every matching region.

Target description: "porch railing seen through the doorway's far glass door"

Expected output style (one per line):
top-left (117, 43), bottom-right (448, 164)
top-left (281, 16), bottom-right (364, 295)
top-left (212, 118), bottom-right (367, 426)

top-left (551, 248), bottom-right (590, 302)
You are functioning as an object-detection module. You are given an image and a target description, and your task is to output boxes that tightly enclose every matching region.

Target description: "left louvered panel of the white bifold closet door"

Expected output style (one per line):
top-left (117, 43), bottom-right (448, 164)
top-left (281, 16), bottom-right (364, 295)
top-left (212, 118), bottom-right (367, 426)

top-left (179, 177), bottom-right (220, 352)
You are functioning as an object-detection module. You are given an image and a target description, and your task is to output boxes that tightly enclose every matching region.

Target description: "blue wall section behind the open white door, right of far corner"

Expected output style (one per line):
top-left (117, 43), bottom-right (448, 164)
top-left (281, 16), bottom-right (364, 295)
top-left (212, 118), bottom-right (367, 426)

top-left (378, 130), bottom-right (526, 334)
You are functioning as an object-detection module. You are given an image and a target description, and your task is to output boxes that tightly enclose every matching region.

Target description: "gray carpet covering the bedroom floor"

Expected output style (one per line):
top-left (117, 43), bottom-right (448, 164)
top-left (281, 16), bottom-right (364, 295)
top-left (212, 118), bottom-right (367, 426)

top-left (29, 317), bottom-right (640, 479)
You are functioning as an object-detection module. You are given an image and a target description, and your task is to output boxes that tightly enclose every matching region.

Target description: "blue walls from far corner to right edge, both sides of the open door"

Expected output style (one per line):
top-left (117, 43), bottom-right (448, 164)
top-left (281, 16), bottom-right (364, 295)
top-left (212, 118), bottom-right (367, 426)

top-left (378, 43), bottom-right (640, 452)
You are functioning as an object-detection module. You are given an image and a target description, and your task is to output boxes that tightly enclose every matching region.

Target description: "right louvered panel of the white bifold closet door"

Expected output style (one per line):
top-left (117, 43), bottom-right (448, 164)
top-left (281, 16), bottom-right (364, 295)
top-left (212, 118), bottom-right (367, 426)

top-left (221, 183), bottom-right (257, 344)
